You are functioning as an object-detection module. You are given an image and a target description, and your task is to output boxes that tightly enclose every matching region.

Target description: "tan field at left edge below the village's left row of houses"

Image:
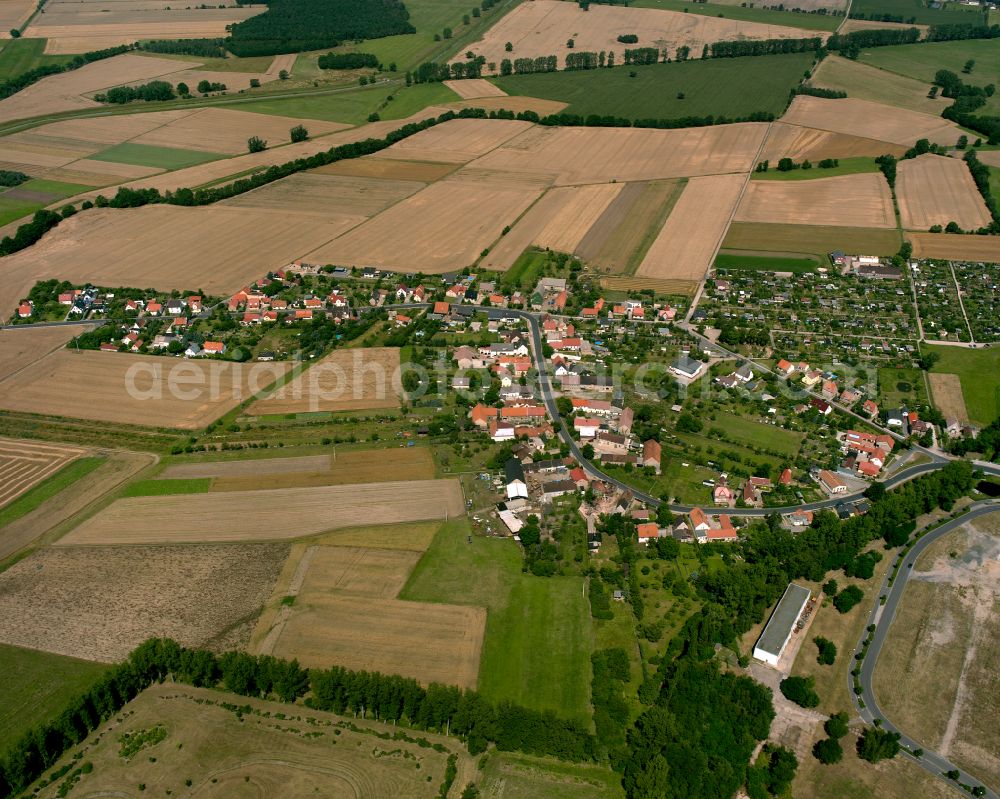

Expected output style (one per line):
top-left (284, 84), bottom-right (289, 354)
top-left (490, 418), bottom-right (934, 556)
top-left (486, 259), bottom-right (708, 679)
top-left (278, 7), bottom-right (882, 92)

top-left (0, 349), bottom-right (288, 430)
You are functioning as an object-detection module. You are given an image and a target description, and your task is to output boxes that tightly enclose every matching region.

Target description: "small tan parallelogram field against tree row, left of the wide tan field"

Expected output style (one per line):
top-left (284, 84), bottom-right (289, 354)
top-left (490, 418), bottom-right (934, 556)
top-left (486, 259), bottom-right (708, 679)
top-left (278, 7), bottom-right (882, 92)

top-left (379, 119), bottom-right (532, 164)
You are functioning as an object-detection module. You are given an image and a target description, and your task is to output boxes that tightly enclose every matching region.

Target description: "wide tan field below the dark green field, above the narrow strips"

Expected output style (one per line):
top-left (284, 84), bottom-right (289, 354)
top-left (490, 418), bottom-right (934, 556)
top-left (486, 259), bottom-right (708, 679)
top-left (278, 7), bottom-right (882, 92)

top-left (473, 122), bottom-right (767, 185)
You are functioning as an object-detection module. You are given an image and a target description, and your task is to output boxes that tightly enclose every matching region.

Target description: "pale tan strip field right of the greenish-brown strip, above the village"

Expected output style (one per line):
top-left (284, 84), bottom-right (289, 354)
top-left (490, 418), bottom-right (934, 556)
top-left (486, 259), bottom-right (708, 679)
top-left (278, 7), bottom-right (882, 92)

top-left (636, 175), bottom-right (746, 280)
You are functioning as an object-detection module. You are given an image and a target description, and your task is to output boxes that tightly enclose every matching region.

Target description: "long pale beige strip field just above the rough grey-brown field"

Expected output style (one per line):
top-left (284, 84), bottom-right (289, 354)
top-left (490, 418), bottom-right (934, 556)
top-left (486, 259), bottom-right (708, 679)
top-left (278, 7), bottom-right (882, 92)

top-left (59, 480), bottom-right (465, 546)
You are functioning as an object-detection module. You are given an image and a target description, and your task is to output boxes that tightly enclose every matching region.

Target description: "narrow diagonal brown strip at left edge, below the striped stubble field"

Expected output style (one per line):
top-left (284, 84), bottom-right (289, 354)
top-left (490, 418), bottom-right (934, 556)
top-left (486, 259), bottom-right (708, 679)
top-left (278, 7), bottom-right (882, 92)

top-left (0, 450), bottom-right (156, 560)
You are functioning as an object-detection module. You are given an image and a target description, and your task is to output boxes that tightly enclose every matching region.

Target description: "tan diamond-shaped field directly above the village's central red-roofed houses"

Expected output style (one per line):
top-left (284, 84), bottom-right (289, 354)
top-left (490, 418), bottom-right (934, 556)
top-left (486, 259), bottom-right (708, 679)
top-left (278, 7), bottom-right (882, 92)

top-left (304, 180), bottom-right (541, 274)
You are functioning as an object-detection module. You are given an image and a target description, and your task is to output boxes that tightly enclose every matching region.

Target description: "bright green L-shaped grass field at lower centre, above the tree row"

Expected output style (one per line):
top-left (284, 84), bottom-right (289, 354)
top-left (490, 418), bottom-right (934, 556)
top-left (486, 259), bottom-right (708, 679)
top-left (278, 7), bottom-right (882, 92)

top-left (399, 519), bottom-right (593, 723)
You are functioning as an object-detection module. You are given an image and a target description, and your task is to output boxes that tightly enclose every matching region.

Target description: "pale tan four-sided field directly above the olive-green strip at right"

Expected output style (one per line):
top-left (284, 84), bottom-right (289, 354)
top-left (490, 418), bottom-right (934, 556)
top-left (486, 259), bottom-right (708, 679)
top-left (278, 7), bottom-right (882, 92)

top-left (735, 172), bottom-right (896, 228)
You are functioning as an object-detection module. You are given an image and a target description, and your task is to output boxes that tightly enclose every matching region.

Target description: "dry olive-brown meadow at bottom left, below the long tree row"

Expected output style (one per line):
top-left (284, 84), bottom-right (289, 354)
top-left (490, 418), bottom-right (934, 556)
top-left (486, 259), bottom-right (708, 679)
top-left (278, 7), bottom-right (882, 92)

top-left (37, 684), bottom-right (466, 799)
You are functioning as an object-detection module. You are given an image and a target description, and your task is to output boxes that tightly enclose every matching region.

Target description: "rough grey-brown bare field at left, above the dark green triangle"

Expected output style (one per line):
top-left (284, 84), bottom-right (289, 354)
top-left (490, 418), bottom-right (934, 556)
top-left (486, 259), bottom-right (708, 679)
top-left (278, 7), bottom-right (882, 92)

top-left (0, 544), bottom-right (288, 663)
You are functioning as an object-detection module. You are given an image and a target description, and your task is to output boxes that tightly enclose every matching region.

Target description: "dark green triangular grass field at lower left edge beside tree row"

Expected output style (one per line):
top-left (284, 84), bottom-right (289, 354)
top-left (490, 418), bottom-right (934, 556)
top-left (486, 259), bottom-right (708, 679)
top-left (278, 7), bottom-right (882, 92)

top-left (0, 644), bottom-right (107, 752)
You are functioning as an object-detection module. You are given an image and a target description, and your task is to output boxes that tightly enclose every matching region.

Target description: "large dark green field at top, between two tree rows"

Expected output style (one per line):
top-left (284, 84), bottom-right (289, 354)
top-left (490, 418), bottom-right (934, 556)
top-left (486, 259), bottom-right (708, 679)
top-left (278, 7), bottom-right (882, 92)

top-left (495, 53), bottom-right (812, 119)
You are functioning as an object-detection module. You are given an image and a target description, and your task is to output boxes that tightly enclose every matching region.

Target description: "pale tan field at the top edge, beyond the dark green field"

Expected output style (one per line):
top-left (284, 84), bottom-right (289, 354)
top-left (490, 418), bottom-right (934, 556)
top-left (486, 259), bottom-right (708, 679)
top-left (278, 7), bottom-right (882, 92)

top-left (456, 0), bottom-right (825, 69)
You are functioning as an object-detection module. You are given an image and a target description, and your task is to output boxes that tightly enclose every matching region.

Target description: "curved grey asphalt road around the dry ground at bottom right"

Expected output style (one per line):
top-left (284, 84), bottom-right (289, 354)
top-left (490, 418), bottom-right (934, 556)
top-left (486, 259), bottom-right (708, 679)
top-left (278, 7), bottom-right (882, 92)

top-left (847, 500), bottom-right (1000, 799)
